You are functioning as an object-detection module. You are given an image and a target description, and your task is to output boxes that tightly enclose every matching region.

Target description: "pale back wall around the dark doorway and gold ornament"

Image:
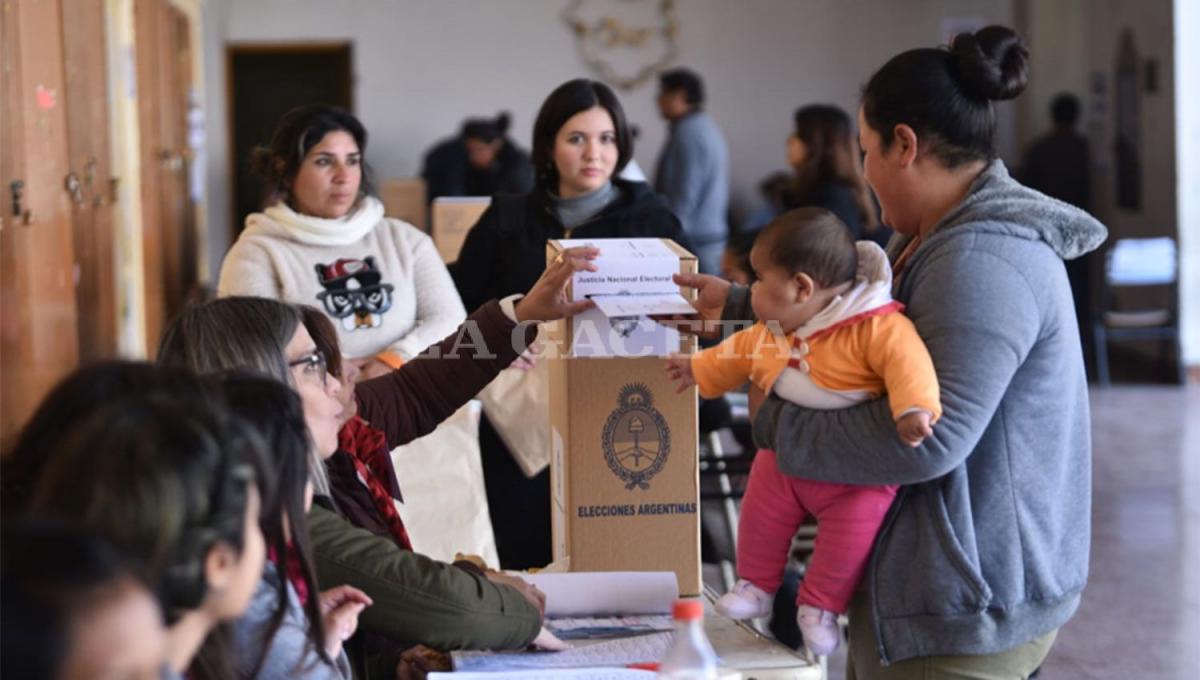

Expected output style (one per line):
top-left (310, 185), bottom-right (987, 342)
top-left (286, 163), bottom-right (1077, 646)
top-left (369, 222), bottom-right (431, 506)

top-left (205, 0), bottom-right (1014, 266)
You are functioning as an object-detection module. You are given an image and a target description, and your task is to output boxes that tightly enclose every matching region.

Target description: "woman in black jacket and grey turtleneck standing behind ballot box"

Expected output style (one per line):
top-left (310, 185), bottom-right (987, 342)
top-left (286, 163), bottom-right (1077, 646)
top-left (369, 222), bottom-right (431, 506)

top-left (451, 79), bottom-right (692, 570)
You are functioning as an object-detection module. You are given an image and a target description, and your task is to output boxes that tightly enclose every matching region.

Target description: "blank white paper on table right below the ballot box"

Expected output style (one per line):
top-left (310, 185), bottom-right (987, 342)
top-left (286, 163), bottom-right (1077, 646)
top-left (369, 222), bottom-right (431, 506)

top-left (521, 571), bottom-right (679, 618)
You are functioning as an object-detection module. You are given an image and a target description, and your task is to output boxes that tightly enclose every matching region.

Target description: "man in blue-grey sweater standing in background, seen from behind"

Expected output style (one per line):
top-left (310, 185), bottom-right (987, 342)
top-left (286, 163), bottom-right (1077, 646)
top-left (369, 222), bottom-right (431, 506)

top-left (654, 68), bottom-right (730, 273)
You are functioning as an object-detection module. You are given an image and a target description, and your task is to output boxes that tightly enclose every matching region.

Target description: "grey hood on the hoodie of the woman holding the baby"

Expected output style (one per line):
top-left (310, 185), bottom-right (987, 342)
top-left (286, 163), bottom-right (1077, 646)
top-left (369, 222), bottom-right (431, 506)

top-left (888, 160), bottom-right (1109, 260)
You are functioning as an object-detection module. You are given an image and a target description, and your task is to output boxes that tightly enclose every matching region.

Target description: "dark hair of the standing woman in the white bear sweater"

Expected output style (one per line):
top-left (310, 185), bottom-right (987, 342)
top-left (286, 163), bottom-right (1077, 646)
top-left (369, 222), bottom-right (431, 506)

top-left (250, 104), bottom-right (374, 207)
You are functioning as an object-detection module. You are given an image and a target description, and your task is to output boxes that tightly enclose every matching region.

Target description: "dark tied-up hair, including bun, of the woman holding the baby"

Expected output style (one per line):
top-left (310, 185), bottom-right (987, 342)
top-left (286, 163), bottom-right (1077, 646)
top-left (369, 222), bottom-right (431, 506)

top-left (863, 26), bottom-right (1028, 169)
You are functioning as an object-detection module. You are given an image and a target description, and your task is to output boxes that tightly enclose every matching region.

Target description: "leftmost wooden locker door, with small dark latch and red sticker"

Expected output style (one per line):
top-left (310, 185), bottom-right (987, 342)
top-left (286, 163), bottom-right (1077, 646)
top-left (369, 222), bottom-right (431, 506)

top-left (0, 0), bottom-right (79, 451)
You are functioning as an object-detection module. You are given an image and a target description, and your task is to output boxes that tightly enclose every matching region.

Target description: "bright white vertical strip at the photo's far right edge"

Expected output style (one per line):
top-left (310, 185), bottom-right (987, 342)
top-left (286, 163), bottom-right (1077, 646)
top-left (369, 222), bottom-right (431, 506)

top-left (1175, 1), bottom-right (1200, 366)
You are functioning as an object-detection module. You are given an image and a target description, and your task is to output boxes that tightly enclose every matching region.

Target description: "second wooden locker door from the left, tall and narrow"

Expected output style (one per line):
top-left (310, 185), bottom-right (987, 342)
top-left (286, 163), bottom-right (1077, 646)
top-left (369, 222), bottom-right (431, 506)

top-left (61, 0), bottom-right (118, 361)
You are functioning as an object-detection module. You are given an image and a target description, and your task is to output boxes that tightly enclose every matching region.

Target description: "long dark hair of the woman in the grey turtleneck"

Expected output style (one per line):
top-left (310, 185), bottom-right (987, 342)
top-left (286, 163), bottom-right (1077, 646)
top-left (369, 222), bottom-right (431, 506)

top-left (532, 78), bottom-right (634, 193)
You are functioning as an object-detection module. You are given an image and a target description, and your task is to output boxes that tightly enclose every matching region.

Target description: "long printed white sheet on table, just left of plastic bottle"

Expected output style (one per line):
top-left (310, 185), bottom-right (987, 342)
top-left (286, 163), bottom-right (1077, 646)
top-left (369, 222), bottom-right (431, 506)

top-left (450, 633), bottom-right (671, 676)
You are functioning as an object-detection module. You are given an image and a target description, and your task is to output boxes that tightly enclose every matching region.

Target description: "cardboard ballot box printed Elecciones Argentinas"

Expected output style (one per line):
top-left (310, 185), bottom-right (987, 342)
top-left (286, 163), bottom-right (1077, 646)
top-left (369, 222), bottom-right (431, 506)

top-left (547, 240), bottom-right (703, 595)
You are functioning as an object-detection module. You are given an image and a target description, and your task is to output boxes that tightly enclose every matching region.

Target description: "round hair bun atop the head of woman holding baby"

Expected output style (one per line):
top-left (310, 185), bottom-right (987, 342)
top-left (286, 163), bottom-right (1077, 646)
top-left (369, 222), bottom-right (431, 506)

top-left (950, 26), bottom-right (1030, 100)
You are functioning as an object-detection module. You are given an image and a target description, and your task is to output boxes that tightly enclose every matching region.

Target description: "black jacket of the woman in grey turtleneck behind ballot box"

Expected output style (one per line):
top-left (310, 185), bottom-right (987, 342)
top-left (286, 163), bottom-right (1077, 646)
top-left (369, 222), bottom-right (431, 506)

top-left (450, 179), bottom-right (691, 309)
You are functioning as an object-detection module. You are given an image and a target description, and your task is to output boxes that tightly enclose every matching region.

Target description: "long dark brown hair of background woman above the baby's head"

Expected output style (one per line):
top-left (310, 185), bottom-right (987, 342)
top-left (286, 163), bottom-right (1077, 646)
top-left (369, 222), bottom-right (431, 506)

top-left (792, 104), bottom-right (878, 233)
